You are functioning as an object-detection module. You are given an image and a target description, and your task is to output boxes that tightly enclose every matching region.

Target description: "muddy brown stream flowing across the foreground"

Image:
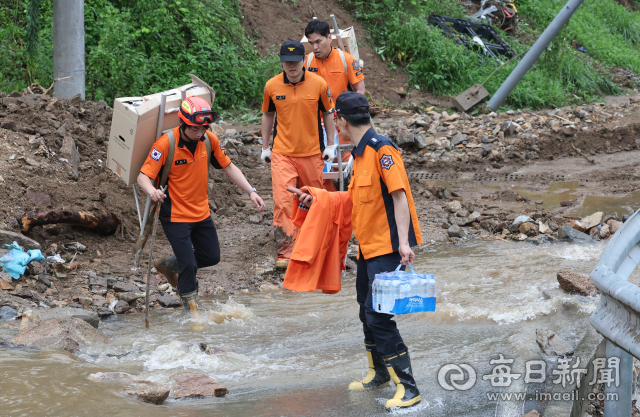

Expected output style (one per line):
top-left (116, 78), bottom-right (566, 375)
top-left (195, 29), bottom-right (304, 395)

top-left (0, 242), bottom-right (632, 417)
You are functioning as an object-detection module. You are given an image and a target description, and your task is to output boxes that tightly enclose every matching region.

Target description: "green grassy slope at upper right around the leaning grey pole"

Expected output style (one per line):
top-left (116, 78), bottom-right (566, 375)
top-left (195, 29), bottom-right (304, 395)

top-left (342, 0), bottom-right (640, 108)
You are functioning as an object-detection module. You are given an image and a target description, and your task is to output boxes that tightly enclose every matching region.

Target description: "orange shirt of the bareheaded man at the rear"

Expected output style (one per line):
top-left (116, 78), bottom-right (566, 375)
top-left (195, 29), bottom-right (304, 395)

top-left (304, 48), bottom-right (364, 102)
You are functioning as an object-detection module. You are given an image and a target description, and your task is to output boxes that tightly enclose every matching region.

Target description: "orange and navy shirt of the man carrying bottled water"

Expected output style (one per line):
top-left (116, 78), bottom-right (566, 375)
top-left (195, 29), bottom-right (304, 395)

top-left (349, 129), bottom-right (422, 259)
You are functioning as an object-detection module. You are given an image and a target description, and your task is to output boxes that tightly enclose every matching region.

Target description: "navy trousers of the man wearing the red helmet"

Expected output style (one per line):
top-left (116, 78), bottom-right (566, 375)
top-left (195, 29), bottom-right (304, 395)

top-left (161, 217), bottom-right (220, 295)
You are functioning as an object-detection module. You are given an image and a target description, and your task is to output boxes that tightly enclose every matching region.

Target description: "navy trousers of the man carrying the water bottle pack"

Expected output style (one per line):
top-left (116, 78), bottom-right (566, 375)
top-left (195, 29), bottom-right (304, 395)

top-left (356, 252), bottom-right (404, 357)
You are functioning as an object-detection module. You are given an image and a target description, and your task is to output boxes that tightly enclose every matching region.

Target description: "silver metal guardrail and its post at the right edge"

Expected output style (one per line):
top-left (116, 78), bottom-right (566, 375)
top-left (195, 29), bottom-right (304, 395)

top-left (589, 211), bottom-right (640, 417)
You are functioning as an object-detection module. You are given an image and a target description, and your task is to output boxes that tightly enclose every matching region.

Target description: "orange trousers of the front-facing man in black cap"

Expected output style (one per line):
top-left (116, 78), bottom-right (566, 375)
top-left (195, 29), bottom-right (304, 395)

top-left (271, 152), bottom-right (324, 260)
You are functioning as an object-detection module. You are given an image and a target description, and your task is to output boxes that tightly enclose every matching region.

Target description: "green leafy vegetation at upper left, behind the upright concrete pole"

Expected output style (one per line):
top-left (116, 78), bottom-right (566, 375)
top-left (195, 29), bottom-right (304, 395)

top-left (0, 0), bottom-right (278, 108)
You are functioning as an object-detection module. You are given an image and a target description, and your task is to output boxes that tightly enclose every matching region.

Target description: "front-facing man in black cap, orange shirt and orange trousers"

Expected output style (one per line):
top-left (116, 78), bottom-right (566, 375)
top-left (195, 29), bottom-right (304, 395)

top-left (261, 41), bottom-right (335, 272)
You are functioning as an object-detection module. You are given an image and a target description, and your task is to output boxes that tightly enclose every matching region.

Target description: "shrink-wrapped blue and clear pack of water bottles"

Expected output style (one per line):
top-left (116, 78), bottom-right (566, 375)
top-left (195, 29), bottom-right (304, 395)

top-left (372, 265), bottom-right (436, 314)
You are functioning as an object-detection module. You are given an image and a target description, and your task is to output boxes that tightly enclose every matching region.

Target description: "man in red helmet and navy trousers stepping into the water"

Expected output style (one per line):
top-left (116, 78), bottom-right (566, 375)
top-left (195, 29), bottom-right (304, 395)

top-left (138, 97), bottom-right (264, 313)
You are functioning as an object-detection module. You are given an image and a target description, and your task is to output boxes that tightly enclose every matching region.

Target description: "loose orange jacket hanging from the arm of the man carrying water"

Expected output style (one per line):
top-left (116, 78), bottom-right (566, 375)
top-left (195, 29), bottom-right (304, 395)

top-left (282, 187), bottom-right (353, 294)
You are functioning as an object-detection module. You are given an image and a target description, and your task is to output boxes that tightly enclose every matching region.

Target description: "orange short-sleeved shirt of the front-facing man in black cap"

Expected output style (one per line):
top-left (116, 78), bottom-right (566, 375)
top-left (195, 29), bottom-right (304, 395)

top-left (262, 71), bottom-right (334, 157)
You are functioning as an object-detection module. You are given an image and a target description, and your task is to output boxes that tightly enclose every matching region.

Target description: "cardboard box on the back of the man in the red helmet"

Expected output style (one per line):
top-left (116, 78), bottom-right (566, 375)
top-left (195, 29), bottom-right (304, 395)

top-left (107, 84), bottom-right (213, 185)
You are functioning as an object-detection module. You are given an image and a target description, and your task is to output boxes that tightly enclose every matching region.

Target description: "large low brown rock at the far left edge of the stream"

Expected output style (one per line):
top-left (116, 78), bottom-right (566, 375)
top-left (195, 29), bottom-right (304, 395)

top-left (11, 317), bottom-right (109, 352)
